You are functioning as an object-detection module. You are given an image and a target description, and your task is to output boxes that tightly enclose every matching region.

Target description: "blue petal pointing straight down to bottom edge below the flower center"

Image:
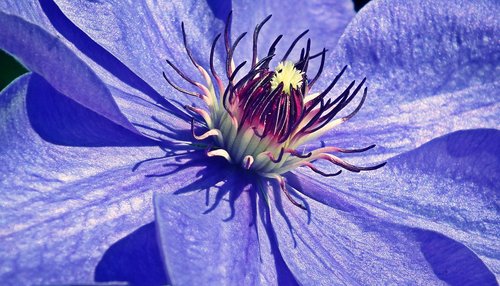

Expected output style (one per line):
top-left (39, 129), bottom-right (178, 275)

top-left (155, 171), bottom-right (259, 285)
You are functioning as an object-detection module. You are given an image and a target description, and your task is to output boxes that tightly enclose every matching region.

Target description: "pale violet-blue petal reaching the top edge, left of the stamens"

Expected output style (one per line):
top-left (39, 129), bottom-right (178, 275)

top-left (49, 1), bottom-right (222, 107)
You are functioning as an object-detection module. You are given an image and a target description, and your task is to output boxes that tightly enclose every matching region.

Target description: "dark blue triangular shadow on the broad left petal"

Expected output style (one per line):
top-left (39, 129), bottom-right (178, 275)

top-left (24, 74), bottom-right (155, 147)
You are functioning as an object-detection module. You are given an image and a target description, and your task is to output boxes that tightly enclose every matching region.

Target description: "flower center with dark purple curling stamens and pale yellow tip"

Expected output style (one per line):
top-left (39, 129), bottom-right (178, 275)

top-left (163, 13), bottom-right (385, 208)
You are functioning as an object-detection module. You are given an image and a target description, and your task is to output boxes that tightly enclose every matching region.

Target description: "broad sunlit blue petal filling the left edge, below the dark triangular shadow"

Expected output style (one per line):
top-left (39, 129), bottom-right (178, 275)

top-left (0, 76), bottom-right (172, 285)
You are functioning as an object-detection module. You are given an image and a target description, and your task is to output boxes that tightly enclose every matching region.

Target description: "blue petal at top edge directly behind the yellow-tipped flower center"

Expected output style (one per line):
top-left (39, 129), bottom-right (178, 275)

top-left (232, 0), bottom-right (355, 71)
